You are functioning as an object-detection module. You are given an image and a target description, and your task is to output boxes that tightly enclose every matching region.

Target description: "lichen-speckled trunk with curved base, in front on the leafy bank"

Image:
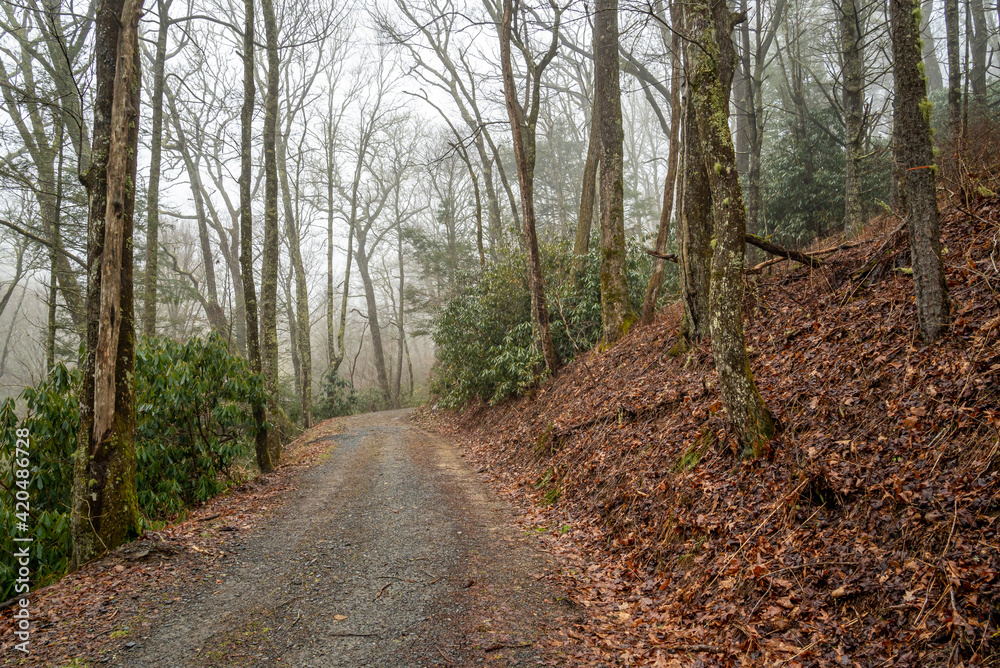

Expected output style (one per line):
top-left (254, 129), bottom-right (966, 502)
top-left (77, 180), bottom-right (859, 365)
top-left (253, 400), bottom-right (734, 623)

top-left (688, 0), bottom-right (775, 456)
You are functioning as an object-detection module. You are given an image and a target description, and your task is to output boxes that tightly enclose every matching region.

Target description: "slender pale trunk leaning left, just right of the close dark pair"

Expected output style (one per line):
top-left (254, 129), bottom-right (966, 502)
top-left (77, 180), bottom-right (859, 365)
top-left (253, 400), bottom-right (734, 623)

top-left (278, 138), bottom-right (312, 429)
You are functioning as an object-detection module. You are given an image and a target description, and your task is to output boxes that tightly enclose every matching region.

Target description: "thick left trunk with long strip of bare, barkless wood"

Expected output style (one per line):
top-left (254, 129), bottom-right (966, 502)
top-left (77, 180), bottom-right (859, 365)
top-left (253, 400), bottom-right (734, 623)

top-left (70, 0), bottom-right (142, 567)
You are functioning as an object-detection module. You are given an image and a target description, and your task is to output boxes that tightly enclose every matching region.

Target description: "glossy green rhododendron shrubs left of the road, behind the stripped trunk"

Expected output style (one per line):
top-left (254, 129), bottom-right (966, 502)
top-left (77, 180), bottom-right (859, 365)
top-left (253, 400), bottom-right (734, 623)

top-left (0, 334), bottom-right (265, 598)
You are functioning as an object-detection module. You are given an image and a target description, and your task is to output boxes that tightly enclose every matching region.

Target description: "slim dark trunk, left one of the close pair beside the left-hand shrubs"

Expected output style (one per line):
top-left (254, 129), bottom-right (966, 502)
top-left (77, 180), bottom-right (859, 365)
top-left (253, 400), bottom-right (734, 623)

top-left (240, 0), bottom-right (274, 473)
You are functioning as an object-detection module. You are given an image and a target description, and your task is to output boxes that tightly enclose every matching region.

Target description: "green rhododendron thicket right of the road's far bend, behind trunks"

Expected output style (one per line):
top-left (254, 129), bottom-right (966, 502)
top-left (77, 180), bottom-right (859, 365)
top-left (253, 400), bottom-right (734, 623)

top-left (431, 244), bottom-right (656, 407)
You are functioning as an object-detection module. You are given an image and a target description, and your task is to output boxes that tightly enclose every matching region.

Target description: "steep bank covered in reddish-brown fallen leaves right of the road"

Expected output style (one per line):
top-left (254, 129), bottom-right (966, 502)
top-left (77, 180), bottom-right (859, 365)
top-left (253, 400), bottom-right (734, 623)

top-left (424, 198), bottom-right (1000, 666)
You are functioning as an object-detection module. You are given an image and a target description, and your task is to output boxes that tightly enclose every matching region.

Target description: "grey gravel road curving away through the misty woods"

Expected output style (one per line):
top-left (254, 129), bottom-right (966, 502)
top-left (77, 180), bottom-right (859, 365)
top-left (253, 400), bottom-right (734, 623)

top-left (113, 411), bottom-right (577, 667)
